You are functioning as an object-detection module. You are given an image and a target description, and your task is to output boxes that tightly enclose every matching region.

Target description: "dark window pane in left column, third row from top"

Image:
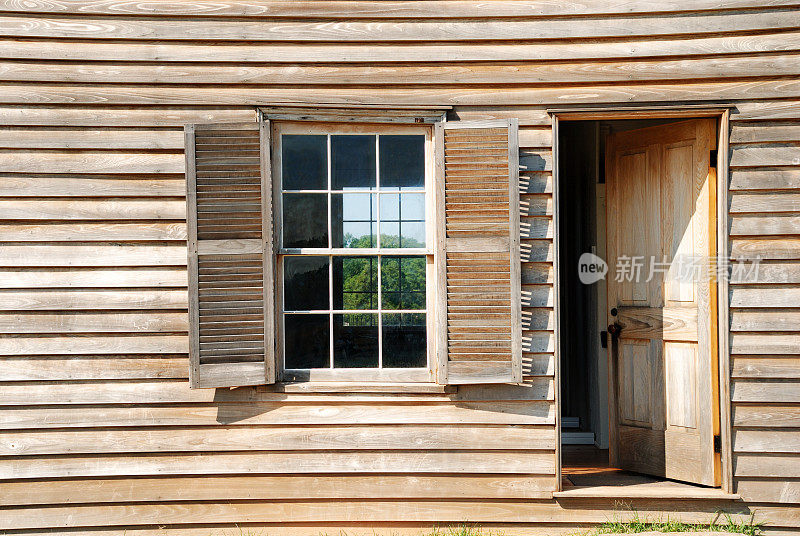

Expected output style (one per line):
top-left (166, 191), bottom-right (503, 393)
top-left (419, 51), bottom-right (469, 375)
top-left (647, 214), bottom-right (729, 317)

top-left (283, 256), bottom-right (330, 311)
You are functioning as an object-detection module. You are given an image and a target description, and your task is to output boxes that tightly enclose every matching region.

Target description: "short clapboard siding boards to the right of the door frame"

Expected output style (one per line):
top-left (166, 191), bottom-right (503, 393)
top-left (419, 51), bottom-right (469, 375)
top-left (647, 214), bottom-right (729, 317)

top-left (729, 97), bottom-right (800, 503)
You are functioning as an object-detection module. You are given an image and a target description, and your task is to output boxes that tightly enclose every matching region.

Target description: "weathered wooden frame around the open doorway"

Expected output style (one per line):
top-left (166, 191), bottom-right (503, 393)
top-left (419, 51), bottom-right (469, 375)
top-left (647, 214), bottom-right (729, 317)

top-left (547, 104), bottom-right (734, 493)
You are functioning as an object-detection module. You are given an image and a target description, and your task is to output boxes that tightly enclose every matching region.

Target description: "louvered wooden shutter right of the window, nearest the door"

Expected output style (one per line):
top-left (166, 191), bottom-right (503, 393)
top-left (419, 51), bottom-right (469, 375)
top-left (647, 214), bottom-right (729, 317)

top-left (436, 120), bottom-right (522, 384)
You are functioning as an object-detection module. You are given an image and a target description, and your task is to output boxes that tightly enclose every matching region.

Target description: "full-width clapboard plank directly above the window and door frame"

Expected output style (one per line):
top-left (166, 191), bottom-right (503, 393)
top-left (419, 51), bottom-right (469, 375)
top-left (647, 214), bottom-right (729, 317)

top-left (0, 78), bottom-right (800, 107)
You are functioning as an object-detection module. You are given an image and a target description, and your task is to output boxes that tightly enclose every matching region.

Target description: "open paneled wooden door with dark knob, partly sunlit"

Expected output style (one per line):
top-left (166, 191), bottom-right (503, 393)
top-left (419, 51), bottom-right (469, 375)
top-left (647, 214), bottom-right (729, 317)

top-left (606, 119), bottom-right (720, 486)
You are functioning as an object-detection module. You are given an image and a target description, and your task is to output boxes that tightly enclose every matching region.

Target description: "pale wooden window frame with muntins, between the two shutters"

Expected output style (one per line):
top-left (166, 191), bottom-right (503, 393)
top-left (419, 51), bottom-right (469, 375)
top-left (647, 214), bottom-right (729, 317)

top-left (271, 121), bottom-right (437, 383)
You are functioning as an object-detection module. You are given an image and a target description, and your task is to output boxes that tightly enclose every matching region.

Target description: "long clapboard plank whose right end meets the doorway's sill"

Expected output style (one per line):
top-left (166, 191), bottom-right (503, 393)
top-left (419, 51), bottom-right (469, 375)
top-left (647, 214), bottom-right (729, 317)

top-left (0, 473), bottom-right (555, 506)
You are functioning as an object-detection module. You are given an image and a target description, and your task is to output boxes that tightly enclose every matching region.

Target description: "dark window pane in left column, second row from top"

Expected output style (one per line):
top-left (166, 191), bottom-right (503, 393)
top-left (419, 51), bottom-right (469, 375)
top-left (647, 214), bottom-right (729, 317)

top-left (283, 194), bottom-right (328, 248)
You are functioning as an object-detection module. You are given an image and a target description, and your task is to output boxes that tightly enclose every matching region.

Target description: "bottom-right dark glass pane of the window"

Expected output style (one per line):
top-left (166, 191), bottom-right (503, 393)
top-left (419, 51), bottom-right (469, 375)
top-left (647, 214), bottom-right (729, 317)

top-left (382, 313), bottom-right (428, 368)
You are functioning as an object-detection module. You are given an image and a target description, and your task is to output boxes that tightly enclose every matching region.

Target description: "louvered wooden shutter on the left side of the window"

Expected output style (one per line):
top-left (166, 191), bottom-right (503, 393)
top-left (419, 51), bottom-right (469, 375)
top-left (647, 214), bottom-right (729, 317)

top-left (186, 123), bottom-right (275, 388)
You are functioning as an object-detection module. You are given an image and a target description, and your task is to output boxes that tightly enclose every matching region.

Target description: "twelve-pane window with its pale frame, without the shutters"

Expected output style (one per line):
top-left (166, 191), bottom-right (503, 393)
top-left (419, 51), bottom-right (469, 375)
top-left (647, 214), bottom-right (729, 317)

top-left (273, 123), bottom-right (433, 381)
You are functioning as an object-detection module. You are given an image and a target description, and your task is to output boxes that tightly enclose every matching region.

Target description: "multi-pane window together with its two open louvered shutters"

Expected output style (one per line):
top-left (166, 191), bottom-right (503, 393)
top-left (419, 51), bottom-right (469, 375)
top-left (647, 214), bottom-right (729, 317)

top-left (186, 116), bottom-right (524, 389)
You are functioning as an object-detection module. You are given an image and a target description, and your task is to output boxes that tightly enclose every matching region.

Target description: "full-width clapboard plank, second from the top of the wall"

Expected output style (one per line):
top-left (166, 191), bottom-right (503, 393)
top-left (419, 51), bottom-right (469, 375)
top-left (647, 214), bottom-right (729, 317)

top-left (3, 8), bottom-right (797, 43)
